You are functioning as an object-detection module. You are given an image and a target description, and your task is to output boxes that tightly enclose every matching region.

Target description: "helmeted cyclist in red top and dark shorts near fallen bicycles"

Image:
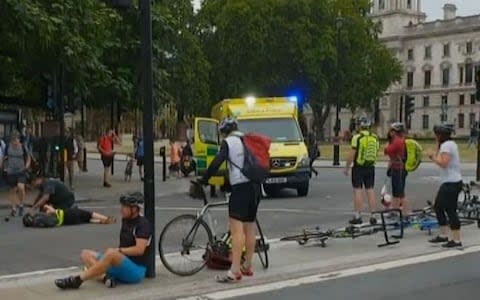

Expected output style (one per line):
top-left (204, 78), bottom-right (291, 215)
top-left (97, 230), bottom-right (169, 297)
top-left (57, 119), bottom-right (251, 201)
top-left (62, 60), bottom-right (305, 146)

top-left (385, 123), bottom-right (407, 212)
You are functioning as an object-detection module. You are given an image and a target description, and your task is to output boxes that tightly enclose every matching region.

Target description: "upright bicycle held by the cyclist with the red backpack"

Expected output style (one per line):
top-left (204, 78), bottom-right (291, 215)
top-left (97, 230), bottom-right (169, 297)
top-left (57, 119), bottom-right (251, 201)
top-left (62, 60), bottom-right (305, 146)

top-left (158, 181), bottom-right (269, 276)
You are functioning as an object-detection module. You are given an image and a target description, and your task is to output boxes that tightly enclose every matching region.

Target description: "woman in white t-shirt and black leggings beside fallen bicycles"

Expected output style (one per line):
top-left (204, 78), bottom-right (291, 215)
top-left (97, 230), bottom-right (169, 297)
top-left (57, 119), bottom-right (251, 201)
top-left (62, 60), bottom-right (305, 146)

top-left (429, 125), bottom-right (463, 248)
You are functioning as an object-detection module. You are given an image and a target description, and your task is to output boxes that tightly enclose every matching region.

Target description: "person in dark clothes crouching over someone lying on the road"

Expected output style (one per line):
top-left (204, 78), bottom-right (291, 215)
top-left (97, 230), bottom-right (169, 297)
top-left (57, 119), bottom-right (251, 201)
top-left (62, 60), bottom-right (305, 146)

top-left (32, 176), bottom-right (75, 210)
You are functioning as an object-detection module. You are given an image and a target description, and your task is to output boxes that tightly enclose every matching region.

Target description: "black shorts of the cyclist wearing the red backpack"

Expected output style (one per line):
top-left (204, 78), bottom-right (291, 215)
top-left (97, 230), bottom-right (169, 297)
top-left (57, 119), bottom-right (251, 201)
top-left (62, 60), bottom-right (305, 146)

top-left (228, 182), bottom-right (262, 223)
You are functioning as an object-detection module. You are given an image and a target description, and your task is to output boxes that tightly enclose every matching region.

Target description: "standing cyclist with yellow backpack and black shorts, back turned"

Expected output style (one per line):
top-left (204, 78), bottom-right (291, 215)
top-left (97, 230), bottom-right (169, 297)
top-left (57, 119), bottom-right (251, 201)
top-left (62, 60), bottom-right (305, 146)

top-left (345, 118), bottom-right (380, 224)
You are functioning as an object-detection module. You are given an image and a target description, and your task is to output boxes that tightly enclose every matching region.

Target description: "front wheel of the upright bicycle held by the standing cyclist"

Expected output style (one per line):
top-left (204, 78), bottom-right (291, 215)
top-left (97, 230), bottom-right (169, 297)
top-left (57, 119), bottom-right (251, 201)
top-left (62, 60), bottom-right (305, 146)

top-left (158, 215), bottom-right (213, 276)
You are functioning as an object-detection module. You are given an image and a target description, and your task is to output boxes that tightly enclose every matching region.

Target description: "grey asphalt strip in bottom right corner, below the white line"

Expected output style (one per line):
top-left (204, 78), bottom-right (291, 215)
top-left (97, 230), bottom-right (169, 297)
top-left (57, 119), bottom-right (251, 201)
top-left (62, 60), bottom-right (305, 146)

top-left (228, 252), bottom-right (480, 300)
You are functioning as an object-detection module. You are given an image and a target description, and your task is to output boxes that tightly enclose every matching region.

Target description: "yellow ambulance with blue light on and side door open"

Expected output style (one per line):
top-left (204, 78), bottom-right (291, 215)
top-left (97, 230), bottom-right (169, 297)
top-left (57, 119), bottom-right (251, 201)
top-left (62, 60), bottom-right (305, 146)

top-left (194, 97), bottom-right (310, 196)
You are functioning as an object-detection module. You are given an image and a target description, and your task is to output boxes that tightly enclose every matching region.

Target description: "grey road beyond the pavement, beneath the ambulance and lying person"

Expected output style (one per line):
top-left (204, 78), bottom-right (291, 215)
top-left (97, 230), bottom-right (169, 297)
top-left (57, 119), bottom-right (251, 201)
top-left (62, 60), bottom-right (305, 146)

top-left (0, 168), bottom-right (473, 276)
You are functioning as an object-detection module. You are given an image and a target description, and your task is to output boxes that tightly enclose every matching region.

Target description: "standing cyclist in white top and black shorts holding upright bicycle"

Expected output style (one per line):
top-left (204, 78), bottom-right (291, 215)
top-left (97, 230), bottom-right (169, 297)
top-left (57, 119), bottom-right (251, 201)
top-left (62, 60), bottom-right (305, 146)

top-left (200, 118), bottom-right (261, 283)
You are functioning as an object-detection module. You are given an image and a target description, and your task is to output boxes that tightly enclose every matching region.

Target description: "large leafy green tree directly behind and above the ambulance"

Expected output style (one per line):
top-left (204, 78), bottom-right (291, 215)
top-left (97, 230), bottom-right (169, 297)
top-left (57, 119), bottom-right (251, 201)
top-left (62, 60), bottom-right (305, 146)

top-left (198, 0), bottom-right (401, 127)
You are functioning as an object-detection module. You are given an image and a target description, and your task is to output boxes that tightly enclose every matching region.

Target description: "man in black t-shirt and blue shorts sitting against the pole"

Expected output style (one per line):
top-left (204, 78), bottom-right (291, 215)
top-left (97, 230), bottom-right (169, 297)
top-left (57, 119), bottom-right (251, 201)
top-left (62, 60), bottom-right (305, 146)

top-left (55, 193), bottom-right (152, 289)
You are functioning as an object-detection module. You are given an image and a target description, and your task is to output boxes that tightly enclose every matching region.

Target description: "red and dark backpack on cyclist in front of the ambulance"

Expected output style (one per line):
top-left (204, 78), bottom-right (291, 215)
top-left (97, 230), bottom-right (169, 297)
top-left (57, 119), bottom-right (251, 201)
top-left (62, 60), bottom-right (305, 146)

top-left (230, 133), bottom-right (272, 183)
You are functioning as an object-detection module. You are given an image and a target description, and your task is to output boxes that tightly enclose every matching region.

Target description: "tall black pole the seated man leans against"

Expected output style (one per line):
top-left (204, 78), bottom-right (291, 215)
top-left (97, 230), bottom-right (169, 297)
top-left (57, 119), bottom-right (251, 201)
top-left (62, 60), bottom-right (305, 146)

top-left (140, 0), bottom-right (155, 278)
